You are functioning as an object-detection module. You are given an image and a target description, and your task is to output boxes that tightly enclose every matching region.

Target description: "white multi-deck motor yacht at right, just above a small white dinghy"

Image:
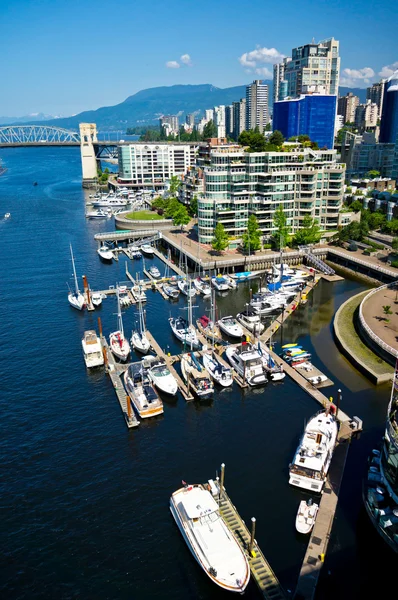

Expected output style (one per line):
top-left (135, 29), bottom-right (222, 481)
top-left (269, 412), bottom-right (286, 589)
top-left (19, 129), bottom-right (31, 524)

top-left (289, 405), bottom-right (338, 493)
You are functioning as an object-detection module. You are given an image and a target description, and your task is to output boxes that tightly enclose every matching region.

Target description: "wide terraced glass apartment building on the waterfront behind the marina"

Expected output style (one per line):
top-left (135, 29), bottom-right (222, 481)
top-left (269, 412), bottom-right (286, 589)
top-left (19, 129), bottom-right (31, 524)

top-left (198, 144), bottom-right (345, 246)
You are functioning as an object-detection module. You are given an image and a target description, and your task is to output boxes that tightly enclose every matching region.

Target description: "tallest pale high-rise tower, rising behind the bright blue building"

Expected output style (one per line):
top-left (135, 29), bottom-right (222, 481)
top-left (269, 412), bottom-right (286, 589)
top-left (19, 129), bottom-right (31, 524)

top-left (283, 38), bottom-right (340, 98)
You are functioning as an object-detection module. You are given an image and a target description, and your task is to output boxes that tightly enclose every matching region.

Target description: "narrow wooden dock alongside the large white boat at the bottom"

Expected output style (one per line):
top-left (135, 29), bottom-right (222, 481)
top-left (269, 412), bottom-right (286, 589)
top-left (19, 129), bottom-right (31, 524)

top-left (219, 487), bottom-right (286, 600)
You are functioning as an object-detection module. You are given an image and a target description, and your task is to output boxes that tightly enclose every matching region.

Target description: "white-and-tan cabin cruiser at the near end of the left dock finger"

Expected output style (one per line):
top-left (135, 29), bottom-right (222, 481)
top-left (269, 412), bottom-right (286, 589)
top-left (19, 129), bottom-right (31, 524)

top-left (123, 362), bottom-right (163, 419)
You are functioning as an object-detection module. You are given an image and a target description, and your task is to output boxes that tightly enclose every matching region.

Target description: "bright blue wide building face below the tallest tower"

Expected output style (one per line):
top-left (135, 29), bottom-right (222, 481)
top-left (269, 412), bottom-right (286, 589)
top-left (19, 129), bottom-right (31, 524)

top-left (273, 95), bottom-right (337, 148)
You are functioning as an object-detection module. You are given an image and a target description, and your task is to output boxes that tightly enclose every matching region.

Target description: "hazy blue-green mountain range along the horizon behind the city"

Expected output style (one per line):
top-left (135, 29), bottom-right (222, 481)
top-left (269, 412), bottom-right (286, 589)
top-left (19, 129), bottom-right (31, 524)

top-left (0, 81), bottom-right (366, 131)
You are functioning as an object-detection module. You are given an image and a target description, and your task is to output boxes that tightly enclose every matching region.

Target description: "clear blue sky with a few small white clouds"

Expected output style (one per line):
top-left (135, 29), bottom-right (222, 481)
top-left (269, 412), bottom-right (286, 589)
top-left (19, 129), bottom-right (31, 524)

top-left (0, 0), bottom-right (398, 117)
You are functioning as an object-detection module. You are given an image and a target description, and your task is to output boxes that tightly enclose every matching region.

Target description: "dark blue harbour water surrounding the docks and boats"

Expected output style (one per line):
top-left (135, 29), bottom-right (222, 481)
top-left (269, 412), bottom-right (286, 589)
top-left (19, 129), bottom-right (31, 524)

top-left (0, 148), bottom-right (393, 600)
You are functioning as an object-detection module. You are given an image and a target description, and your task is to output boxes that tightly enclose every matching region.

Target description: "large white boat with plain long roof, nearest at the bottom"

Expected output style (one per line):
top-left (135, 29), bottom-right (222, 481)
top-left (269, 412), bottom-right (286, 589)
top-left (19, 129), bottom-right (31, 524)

top-left (170, 482), bottom-right (250, 594)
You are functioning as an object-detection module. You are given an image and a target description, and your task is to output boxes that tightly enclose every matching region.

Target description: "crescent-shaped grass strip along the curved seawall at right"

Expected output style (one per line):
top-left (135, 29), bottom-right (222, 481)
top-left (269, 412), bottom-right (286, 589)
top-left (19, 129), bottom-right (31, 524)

top-left (338, 291), bottom-right (393, 375)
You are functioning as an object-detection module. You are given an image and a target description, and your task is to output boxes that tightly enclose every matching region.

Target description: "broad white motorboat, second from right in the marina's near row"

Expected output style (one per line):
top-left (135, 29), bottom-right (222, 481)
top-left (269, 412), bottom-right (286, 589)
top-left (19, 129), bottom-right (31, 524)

top-left (226, 342), bottom-right (268, 386)
